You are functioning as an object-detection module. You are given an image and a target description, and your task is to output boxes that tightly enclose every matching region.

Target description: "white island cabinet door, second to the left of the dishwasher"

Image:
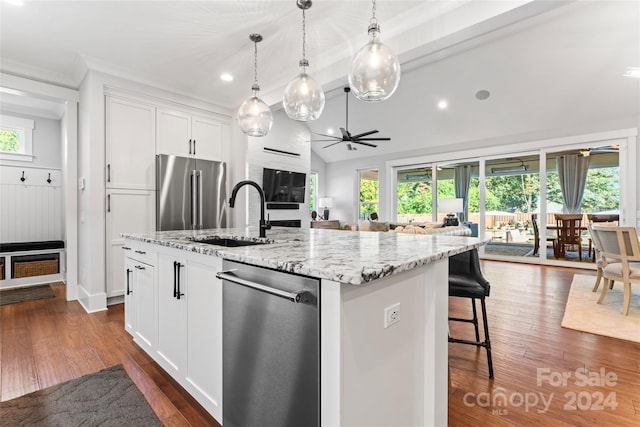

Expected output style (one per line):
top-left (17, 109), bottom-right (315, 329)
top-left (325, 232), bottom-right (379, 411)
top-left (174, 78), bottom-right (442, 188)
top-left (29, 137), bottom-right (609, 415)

top-left (156, 253), bottom-right (191, 381)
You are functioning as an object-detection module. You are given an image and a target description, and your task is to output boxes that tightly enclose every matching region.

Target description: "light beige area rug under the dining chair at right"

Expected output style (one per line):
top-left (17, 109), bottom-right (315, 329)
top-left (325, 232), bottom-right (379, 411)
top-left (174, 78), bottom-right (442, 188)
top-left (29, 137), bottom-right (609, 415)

top-left (562, 274), bottom-right (640, 343)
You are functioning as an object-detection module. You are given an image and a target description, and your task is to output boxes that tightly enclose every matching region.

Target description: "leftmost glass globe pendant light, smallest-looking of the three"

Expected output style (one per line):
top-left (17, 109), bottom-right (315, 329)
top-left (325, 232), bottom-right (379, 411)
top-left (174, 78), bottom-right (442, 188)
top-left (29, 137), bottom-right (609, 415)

top-left (237, 34), bottom-right (273, 136)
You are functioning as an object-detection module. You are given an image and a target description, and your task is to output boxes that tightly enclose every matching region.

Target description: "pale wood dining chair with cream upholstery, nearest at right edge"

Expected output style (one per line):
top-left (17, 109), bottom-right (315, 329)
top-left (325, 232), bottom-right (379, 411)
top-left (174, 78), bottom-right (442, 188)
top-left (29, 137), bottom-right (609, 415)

top-left (591, 224), bottom-right (640, 316)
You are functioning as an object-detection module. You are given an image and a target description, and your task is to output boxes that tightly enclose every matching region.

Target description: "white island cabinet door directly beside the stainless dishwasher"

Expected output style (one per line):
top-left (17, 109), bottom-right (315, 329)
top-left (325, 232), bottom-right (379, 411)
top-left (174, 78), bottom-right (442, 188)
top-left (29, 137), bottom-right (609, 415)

top-left (185, 257), bottom-right (222, 420)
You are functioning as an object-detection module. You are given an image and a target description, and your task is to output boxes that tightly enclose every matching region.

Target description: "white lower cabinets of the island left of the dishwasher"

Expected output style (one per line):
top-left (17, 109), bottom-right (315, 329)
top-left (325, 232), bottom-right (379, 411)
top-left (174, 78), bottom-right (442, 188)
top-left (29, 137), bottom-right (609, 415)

top-left (124, 241), bottom-right (222, 422)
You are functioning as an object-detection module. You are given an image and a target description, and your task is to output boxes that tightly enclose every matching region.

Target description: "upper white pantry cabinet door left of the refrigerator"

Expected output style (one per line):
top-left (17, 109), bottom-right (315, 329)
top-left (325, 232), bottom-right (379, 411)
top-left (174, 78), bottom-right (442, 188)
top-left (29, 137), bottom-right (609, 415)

top-left (105, 96), bottom-right (156, 190)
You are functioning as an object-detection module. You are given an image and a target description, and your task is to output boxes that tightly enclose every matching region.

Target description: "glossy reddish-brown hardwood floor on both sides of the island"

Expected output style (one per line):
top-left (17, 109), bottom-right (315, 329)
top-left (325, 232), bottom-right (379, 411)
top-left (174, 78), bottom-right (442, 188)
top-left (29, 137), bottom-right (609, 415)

top-left (0, 261), bottom-right (640, 426)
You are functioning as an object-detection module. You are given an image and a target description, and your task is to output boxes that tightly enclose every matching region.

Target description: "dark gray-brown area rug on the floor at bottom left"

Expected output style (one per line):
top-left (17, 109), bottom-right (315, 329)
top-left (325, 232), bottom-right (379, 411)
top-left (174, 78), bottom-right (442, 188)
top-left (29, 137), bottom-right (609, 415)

top-left (0, 365), bottom-right (162, 427)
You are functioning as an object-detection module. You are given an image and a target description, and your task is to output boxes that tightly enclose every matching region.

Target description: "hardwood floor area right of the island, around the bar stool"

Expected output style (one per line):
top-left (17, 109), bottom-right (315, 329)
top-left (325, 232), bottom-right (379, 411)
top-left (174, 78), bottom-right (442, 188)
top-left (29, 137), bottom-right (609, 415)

top-left (449, 261), bottom-right (640, 426)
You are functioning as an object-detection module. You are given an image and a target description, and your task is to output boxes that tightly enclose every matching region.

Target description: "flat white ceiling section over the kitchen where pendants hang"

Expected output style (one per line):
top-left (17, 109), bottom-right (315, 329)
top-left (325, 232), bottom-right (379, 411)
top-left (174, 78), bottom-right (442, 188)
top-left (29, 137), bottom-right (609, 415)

top-left (0, 0), bottom-right (560, 109)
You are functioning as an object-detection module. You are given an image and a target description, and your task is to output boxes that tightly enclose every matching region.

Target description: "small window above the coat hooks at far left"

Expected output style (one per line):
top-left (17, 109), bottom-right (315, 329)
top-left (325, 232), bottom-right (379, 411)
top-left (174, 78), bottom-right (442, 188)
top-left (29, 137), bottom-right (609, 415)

top-left (0, 115), bottom-right (34, 162)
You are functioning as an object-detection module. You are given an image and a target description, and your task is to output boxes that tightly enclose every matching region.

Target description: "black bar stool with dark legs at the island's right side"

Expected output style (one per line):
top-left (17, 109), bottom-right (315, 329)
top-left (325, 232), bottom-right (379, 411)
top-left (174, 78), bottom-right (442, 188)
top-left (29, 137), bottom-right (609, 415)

top-left (449, 249), bottom-right (493, 378)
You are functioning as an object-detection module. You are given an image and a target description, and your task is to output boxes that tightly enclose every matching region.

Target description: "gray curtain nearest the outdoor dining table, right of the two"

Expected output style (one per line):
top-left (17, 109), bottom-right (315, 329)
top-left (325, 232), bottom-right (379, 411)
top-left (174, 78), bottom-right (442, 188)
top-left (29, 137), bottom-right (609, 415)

top-left (556, 154), bottom-right (590, 213)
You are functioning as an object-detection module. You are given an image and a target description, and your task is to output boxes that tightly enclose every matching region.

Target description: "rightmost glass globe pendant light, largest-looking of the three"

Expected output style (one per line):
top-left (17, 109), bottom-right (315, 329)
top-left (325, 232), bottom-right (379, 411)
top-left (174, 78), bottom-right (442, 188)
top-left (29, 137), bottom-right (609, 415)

top-left (349, 0), bottom-right (400, 102)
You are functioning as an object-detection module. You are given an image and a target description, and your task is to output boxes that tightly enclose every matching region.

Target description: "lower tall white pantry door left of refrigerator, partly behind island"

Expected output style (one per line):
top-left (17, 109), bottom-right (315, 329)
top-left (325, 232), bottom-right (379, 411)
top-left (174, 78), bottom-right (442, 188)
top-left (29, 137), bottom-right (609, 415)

top-left (106, 189), bottom-right (155, 298)
